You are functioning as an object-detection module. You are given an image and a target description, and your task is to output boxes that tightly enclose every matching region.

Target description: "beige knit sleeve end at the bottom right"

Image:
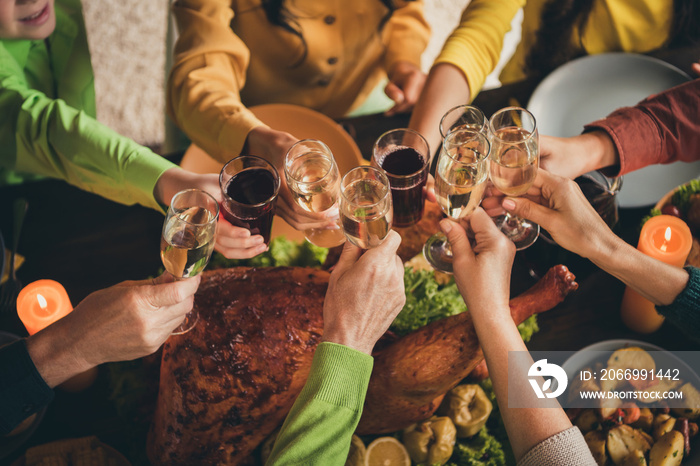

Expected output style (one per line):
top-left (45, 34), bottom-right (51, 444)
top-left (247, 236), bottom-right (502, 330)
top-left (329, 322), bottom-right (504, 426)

top-left (518, 427), bottom-right (596, 466)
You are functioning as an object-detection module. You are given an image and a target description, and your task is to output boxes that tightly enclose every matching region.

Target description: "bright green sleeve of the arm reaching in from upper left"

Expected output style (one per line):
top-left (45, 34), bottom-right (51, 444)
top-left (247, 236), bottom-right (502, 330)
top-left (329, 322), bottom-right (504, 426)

top-left (0, 54), bottom-right (175, 210)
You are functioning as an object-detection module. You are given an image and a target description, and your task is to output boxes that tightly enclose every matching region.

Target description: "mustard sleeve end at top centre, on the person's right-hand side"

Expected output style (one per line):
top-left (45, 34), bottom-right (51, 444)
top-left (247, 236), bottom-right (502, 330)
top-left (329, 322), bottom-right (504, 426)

top-left (384, 0), bottom-right (430, 73)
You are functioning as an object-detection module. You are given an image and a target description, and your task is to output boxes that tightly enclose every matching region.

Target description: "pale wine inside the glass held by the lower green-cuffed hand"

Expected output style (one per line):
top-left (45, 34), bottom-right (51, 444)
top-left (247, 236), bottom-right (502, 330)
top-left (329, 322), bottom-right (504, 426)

top-left (340, 179), bottom-right (393, 249)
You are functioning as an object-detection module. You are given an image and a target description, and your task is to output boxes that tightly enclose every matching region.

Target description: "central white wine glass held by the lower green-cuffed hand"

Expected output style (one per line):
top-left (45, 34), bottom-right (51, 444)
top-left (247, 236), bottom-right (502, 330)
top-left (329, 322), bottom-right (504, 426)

top-left (340, 166), bottom-right (394, 249)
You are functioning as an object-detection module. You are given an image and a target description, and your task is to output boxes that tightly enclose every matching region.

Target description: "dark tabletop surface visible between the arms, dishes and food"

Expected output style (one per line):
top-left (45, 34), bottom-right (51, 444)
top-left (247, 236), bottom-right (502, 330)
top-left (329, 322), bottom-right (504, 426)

top-left (0, 47), bottom-right (700, 464)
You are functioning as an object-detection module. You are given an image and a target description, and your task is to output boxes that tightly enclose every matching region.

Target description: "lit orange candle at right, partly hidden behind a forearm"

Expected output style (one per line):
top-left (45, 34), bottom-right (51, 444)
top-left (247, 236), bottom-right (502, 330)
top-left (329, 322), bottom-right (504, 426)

top-left (621, 215), bottom-right (693, 333)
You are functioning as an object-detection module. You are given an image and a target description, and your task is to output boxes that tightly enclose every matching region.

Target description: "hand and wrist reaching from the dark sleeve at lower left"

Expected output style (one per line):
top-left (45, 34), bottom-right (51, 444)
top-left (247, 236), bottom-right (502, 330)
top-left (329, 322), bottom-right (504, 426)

top-left (27, 273), bottom-right (200, 387)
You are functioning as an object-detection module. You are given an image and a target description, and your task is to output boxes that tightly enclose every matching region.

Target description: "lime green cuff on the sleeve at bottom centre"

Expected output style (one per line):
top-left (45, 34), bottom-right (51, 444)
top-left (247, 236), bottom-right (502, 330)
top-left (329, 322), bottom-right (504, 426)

top-left (304, 342), bottom-right (374, 411)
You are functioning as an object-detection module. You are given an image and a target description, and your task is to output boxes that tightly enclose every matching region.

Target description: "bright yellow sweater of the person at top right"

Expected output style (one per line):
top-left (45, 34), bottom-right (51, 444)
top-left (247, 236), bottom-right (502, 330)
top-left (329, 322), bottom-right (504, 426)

top-left (435, 0), bottom-right (673, 99)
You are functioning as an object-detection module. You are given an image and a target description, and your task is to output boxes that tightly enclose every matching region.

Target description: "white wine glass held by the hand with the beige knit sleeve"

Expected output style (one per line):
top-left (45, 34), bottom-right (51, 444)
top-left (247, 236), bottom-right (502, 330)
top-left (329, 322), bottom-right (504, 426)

top-left (423, 127), bottom-right (491, 273)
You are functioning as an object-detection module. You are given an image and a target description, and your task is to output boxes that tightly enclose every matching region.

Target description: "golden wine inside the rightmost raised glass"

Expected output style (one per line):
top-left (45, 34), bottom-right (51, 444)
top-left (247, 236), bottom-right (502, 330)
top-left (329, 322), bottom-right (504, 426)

top-left (491, 127), bottom-right (539, 196)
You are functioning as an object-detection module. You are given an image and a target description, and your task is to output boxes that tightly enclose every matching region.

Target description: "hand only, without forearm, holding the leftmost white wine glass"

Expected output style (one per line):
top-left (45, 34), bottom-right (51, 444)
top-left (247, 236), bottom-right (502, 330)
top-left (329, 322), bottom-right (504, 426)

top-left (66, 272), bottom-right (201, 366)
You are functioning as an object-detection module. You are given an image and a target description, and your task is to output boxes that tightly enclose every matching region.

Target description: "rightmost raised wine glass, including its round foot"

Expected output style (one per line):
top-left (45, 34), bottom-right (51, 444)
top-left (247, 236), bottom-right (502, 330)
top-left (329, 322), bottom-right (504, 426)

top-left (489, 107), bottom-right (540, 250)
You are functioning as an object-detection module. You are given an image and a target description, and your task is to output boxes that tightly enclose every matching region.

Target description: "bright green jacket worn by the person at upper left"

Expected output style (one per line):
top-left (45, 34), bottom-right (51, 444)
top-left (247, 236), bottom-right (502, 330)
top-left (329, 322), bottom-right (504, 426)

top-left (0, 0), bottom-right (174, 210)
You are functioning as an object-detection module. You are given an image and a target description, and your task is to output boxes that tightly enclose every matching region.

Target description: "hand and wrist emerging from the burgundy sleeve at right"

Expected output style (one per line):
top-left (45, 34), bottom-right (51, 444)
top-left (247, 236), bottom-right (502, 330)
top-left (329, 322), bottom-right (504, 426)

top-left (539, 131), bottom-right (620, 179)
